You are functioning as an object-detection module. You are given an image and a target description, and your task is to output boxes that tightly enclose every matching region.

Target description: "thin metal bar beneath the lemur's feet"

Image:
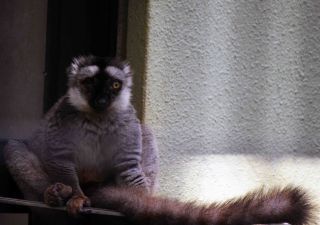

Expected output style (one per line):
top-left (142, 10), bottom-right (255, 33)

top-left (0, 197), bottom-right (123, 216)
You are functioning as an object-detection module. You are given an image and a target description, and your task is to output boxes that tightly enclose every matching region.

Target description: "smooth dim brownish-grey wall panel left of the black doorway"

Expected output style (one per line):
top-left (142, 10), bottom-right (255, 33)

top-left (0, 0), bottom-right (47, 138)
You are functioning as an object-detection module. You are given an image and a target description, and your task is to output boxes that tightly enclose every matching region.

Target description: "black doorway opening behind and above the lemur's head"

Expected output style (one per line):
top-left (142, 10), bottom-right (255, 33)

top-left (43, 0), bottom-right (126, 112)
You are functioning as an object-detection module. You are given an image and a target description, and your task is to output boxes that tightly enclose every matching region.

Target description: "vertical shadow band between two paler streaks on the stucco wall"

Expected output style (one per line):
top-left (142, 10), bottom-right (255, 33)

top-left (226, 1), bottom-right (270, 154)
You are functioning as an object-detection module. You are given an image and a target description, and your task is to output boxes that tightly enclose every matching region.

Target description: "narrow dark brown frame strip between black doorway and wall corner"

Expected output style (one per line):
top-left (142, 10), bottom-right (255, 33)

top-left (116, 0), bottom-right (128, 59)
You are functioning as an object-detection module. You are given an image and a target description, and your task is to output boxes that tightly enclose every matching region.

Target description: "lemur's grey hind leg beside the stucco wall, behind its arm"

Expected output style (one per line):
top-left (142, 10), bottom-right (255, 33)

top-left (141, 125), bottom-right (159, 192)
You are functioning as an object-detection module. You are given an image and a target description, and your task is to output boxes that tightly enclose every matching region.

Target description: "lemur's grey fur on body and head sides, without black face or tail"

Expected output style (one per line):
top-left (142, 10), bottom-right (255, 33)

top-left (5, 56), bottom-right (158, 206)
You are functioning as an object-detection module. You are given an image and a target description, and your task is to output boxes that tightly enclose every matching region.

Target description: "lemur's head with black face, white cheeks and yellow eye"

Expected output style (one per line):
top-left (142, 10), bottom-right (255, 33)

top-left (68, 56), bottom-right (132, 113)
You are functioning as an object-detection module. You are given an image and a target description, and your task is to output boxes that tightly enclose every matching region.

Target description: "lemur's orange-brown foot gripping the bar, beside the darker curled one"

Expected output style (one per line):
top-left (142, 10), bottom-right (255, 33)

top-left (67, 195), bottom-right (90, 216)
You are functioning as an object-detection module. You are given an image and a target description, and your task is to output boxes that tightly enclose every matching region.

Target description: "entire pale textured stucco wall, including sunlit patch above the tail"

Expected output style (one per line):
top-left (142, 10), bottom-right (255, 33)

top-left (128, 0), bottom-right (320, 204)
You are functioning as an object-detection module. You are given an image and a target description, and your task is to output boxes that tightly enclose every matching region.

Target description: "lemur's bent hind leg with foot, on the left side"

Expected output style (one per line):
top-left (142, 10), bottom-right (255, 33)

top-left (4, 140), bottom-right (72, 206)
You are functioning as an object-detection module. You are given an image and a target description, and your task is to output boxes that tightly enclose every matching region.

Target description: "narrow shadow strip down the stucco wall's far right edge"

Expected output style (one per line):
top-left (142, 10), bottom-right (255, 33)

top-left (297, 0), bottom-right (320, 156)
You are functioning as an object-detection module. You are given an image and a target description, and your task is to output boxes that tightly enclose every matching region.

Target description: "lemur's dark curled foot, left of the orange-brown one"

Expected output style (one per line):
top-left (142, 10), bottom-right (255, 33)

top-left (44, 183), bottom-right (72, 206)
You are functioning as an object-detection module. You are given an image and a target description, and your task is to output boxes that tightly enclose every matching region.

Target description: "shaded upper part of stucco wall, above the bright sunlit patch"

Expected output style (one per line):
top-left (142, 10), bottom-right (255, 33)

top-left (146, 0), bottom-right (320, 159)
